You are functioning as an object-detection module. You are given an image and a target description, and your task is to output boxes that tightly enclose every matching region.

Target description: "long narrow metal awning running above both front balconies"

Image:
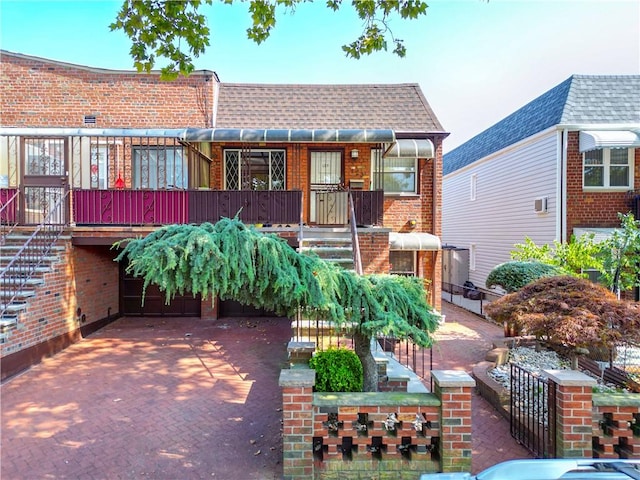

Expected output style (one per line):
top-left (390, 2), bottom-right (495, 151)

top-left (0, 127), bottom-right (396, 143)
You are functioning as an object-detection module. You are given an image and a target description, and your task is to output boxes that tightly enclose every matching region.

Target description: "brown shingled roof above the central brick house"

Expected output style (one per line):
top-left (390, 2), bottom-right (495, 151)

top-left (214, 83), bottom-right (443, 133)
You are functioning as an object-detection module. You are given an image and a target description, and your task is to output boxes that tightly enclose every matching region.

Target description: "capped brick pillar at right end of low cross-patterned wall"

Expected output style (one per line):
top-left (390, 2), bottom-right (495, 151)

top-left (431, 370), bottom-right (476, 472)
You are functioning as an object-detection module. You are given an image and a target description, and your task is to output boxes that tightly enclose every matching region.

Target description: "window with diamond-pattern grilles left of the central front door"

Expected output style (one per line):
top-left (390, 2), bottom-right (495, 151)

top-left (224, 150), bottom-right (286, 190)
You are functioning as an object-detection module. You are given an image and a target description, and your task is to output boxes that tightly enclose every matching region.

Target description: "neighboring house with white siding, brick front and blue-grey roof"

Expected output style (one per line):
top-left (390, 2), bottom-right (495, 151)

top-left (442, 75), bottom-right (640, 289)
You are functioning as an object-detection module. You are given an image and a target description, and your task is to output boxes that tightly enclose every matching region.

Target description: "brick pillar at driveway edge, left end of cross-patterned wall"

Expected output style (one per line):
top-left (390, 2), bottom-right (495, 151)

top-left (279, 368), bottom-right (316, 480)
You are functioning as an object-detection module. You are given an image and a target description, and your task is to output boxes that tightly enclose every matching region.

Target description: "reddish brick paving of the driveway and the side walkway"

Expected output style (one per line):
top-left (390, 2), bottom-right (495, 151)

top-left (0, 304), bottom-right (529, 480)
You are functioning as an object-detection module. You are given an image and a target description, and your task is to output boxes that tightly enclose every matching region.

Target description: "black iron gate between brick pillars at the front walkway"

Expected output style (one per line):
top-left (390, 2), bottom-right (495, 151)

top-left (510, 363), bottom-right (556, 458)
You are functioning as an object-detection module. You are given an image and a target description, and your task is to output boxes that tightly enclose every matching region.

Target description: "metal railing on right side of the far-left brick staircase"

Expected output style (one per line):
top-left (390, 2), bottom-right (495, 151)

top-left (0, 191), bottom-right (69, 318)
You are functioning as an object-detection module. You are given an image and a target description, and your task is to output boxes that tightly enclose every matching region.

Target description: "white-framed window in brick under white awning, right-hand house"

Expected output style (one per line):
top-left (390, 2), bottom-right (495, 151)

top-left (583, 148), bottom-right (633, 190)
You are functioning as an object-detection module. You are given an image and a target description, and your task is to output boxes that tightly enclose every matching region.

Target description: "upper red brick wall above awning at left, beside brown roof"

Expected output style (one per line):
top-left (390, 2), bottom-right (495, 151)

top-left (0, 53), bottom-right (216, 128)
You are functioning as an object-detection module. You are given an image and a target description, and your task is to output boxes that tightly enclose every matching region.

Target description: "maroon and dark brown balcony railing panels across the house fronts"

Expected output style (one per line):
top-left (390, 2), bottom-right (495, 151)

top-left (0, 188), bottom-right (384, 226)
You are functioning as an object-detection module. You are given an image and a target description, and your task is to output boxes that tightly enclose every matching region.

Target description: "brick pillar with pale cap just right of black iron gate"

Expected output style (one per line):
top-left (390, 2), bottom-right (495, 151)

top-left (545, 370), bottom-right (597, 458)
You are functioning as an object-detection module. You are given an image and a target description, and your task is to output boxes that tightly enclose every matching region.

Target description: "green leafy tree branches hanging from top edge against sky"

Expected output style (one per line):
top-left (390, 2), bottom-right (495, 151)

top-left (110, 0), bottom-right (427, 79)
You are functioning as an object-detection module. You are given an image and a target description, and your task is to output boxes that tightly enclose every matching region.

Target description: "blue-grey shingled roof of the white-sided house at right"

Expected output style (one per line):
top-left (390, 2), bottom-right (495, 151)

top-left (443, 75), bottom-right (640, 175)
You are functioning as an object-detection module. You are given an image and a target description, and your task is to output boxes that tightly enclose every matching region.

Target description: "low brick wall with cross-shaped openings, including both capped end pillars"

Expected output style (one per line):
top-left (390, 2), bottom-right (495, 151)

top-left (280, 366), bottom-right (474, 480)
